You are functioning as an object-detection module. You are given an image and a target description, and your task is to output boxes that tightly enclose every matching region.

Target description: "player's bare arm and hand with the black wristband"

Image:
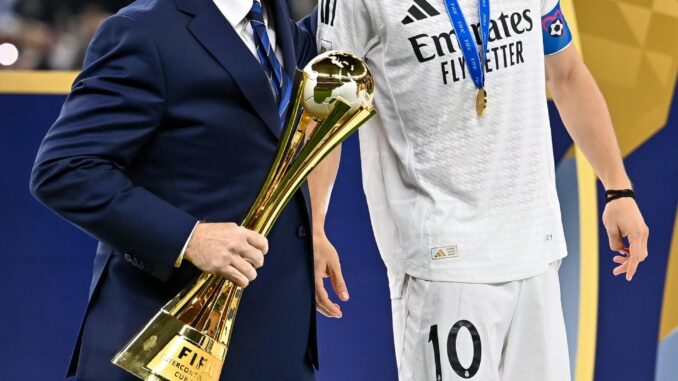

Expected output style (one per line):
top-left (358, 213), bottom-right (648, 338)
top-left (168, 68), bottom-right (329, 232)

top-left (546, 45), bottom-right (649, 280)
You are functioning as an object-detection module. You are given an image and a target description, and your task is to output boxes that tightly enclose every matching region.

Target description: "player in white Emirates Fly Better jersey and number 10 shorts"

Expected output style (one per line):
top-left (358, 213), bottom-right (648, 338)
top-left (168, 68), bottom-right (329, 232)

top-left (311, 0), bottom-right (648, 381)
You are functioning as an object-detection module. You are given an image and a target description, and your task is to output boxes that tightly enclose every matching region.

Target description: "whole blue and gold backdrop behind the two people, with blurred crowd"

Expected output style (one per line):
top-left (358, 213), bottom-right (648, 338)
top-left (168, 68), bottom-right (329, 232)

top-left (0, 0), bottom-right (678, 381)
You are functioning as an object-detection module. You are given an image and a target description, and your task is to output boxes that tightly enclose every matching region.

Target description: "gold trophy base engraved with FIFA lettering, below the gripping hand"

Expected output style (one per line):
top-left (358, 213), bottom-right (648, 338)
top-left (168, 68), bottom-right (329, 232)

top-left (113, 310), bottom-right (227, 381)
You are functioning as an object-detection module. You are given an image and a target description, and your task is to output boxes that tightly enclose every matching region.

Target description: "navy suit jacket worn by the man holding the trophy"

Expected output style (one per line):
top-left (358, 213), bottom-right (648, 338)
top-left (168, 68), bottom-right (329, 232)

top-left (31, 0), bottom-right (317, 380)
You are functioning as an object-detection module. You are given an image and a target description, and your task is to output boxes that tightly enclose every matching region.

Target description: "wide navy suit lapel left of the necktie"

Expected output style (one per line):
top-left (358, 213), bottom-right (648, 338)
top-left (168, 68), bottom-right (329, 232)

top-left (176, 0), bottom-right (281, 138)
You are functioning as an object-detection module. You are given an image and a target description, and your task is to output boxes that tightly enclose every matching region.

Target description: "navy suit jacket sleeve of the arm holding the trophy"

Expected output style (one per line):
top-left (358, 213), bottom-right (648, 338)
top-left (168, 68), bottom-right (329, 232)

top-left (31, 15), bottom-right (197, 280)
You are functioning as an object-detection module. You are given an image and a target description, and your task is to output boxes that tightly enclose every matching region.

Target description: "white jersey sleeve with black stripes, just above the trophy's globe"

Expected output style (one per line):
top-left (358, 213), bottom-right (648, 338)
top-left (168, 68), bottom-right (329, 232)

top-left (316, 0), bottom-right (378, 58)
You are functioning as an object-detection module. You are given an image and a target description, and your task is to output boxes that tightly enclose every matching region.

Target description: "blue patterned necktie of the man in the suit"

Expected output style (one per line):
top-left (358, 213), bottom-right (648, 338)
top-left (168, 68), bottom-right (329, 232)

top-left (247, 0), bottom-right (292, 129)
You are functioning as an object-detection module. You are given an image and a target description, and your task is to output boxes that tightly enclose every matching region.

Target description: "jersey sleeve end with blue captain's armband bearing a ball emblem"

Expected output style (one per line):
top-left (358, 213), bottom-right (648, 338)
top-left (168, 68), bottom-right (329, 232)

top-left (541, 0), bottom-right (572, 56)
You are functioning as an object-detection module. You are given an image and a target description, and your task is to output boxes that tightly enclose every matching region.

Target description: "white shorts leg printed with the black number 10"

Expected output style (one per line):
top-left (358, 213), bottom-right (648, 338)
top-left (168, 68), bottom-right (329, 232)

top-left (399, 278), bottom-right (518, 381)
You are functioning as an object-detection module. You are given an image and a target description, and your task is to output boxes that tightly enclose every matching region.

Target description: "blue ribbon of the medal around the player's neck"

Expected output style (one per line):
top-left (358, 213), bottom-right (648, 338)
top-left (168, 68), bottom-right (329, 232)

top-left (445, 0), bottom-right (490, 90)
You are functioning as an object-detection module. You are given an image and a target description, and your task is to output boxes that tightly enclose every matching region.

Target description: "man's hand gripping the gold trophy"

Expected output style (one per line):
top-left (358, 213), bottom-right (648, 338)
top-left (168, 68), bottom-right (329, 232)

top-left (184, 223), bottom-right (268, 287)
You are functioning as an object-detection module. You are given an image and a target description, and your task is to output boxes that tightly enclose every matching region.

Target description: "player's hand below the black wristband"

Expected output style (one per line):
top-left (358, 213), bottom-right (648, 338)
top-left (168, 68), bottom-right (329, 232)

top-left (603, 198), bottom-right (650, 281)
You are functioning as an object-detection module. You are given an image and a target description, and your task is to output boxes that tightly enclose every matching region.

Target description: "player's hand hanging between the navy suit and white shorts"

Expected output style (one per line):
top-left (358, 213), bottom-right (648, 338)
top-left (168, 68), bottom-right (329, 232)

top-left (313, 233), bottom-right (349, 318)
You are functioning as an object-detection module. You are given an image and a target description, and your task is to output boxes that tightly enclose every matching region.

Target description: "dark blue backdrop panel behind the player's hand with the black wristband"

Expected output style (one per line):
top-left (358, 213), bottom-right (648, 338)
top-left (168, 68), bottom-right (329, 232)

top-left (594, 95), bottom-right (678, 381)
